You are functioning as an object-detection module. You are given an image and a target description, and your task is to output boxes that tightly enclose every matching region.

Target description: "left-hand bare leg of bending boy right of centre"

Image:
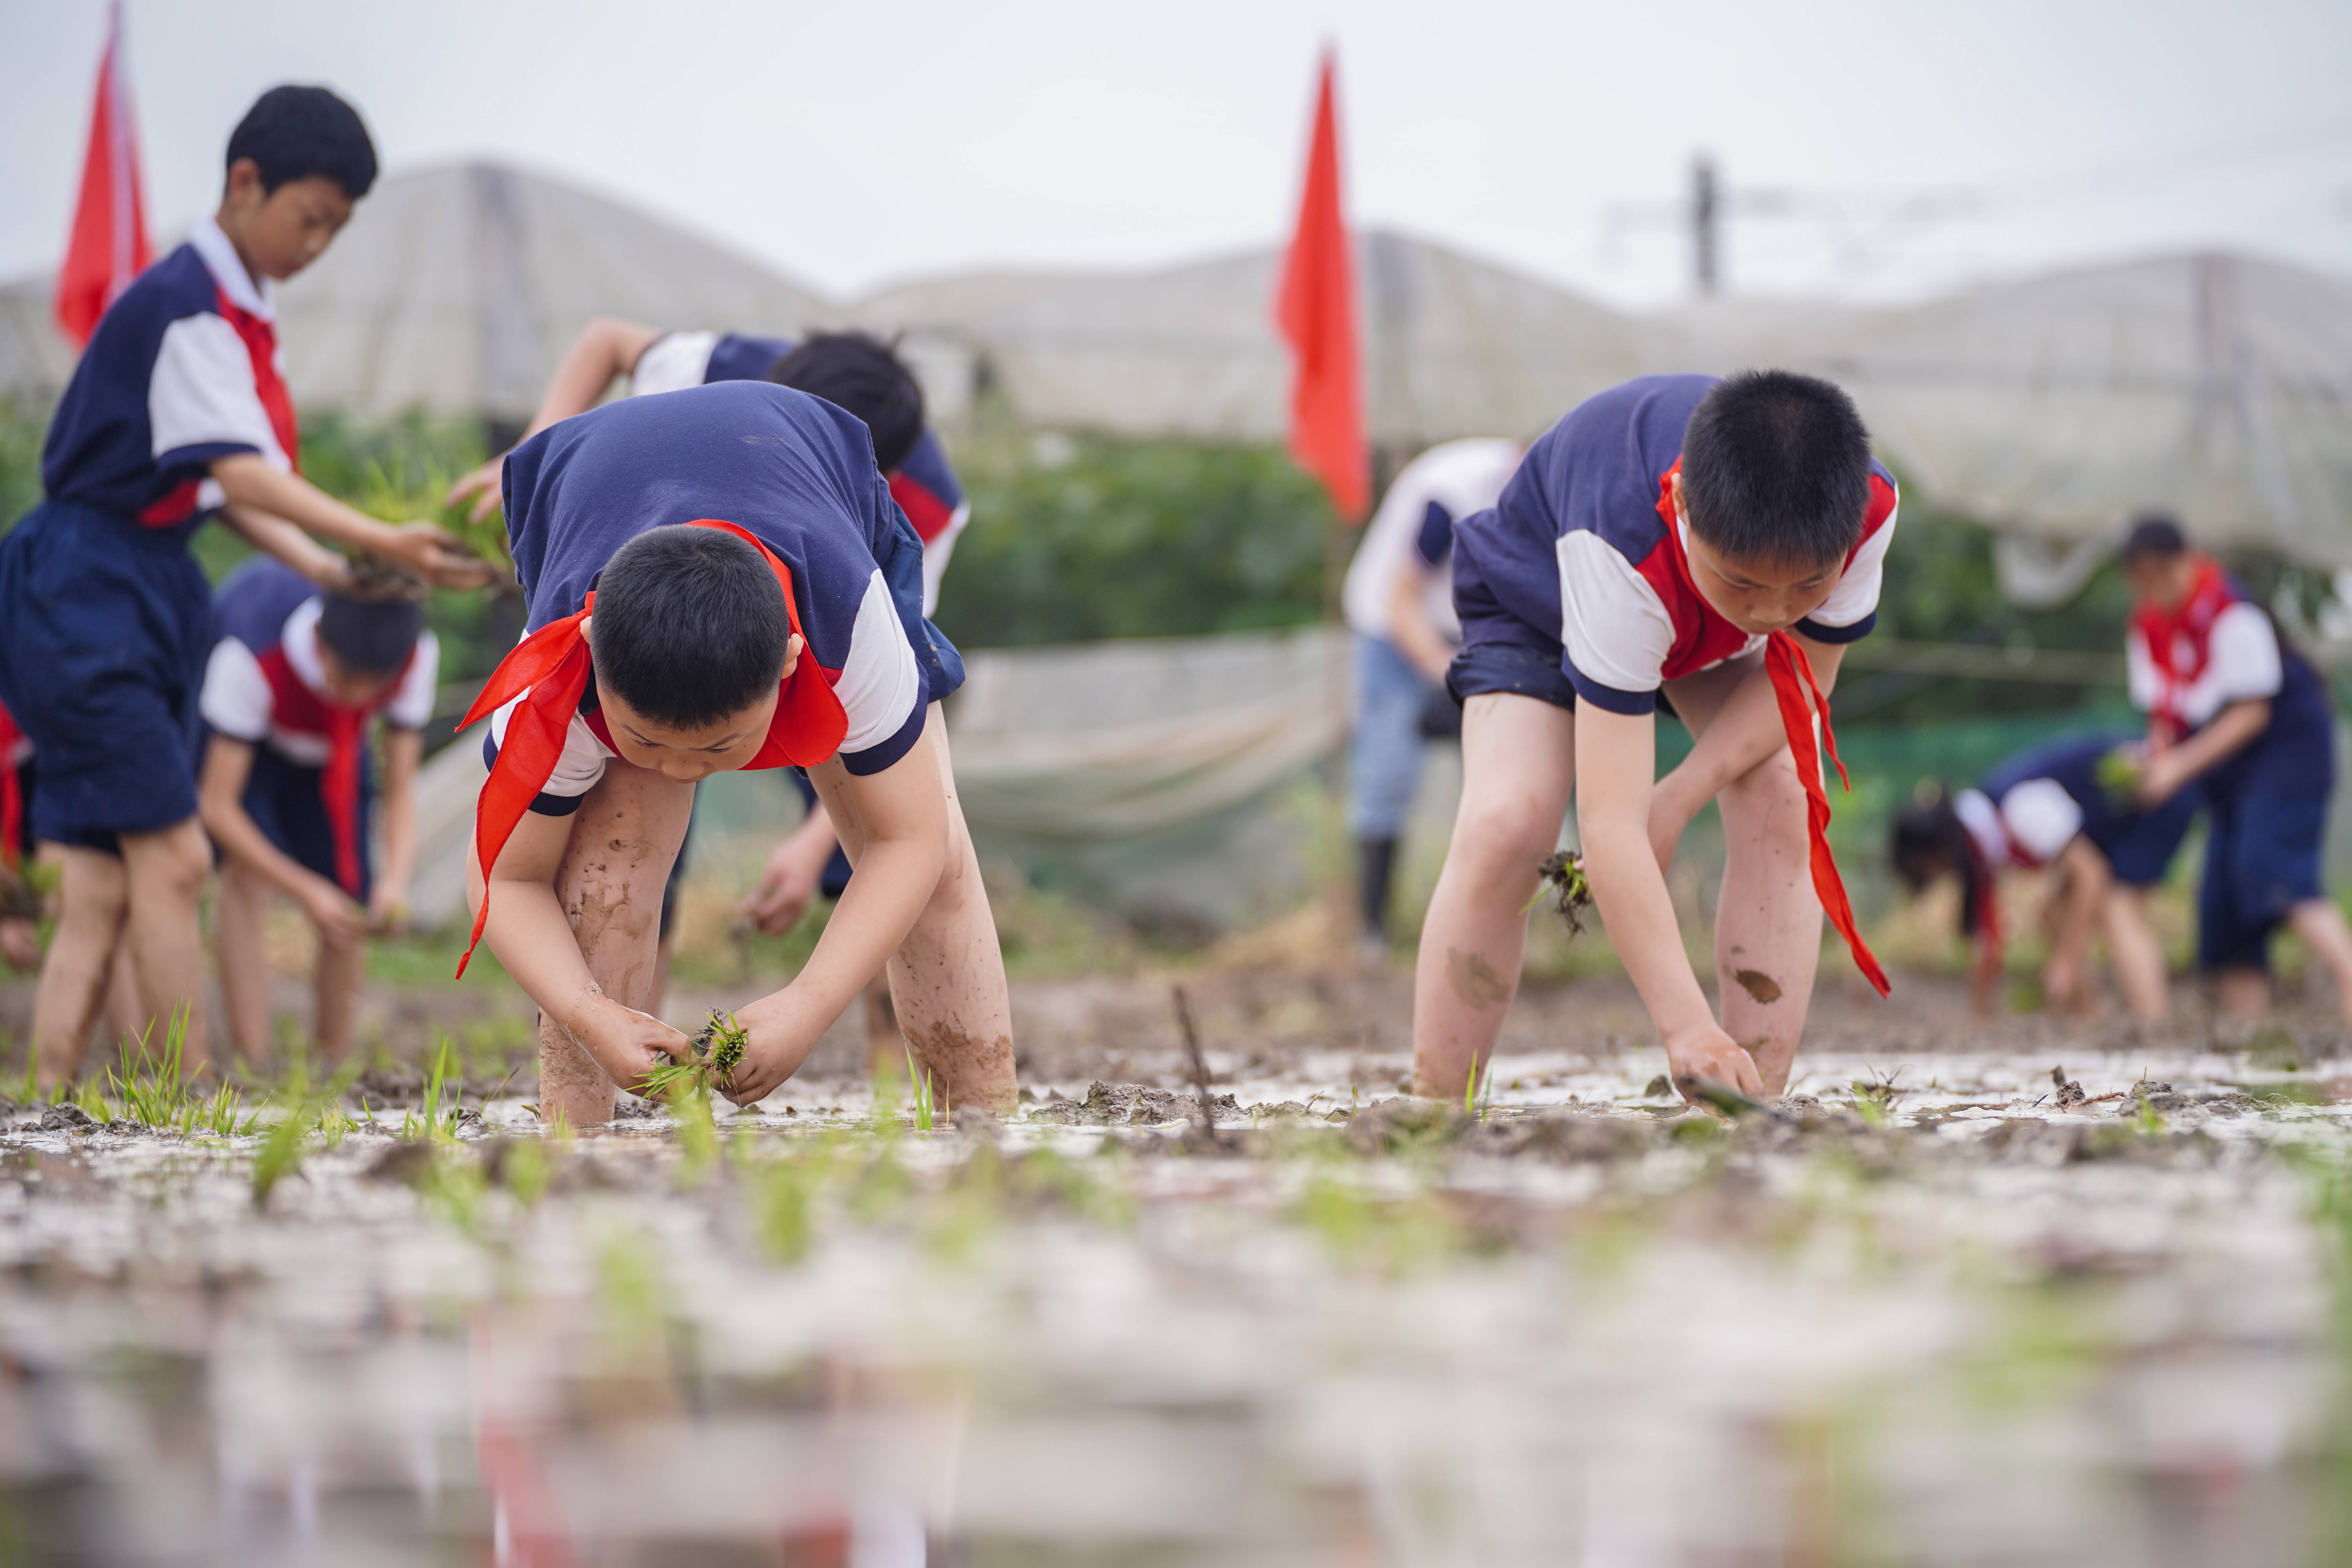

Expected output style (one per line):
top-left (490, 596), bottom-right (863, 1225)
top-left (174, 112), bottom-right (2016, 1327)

top-left (1414, 693), bottom-right (1576, 1100)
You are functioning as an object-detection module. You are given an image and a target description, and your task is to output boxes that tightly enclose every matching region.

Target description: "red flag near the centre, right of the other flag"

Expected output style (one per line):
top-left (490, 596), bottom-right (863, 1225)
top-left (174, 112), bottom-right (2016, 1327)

top-left (1275, 49), bottom-right (1371, 522)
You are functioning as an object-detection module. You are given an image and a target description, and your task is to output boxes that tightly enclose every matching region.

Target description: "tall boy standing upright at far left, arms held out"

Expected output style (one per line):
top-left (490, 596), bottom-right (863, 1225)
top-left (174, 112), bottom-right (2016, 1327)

top-left (0, 87), bottom-right (485, 1086)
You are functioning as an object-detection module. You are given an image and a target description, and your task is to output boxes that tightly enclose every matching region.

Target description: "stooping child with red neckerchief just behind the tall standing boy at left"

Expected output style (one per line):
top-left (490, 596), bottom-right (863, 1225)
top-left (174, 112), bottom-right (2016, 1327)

top-left (200, 559), bottom-right (440, 1063)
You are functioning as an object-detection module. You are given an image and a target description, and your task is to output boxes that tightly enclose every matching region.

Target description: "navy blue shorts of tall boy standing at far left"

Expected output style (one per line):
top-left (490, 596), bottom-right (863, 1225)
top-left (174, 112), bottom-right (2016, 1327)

top-left (0, 501), bottom-right (212, 851)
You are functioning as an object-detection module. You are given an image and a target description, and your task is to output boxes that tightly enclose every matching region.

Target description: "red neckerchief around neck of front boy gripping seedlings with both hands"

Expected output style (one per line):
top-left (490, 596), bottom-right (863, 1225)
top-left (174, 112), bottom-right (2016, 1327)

top-left (456, 517), bottom-right (849, 976)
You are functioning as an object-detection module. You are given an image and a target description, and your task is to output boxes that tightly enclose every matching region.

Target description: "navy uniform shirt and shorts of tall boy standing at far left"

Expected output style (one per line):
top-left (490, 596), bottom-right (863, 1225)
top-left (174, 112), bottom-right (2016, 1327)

top-left (0, 219), bottom-right (296, 851)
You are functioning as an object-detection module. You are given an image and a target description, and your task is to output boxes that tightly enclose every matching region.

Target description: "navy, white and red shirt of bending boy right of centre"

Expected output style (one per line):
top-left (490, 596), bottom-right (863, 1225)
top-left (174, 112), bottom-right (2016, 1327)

top-left (1454, 376), bottom-right (1896, 715)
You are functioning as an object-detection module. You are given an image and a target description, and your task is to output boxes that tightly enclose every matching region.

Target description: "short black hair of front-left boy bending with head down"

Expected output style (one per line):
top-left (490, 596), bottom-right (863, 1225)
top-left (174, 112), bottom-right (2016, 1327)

top-left (588, 524), bottom-right (793, 729)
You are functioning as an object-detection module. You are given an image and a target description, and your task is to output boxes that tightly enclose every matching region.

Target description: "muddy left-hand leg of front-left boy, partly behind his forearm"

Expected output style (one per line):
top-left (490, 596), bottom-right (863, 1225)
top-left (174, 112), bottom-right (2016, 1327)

top-left (539, 757), bottom-right (694, 1126)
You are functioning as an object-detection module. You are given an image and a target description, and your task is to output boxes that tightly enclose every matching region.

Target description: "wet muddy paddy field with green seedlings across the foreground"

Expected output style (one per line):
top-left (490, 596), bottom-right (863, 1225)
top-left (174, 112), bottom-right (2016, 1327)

top-left (0, 971), bottom-right (2352, 1568)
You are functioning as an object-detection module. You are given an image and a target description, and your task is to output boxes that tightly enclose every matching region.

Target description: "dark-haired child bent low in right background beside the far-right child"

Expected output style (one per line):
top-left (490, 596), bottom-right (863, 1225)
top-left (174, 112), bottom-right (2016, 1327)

top-left (1893, 736), bottom-right (2197, 1023)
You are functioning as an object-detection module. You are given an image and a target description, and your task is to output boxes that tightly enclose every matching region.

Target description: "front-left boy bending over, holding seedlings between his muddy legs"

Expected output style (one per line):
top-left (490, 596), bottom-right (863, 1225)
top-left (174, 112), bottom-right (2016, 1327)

top-left (461, 381), bottom-right (1014, 1126)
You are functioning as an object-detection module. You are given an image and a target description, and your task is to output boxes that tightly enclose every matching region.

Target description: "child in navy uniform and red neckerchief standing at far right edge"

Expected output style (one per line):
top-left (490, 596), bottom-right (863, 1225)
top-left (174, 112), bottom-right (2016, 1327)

top-left (2124, 517), bottom-right (2352, 1020)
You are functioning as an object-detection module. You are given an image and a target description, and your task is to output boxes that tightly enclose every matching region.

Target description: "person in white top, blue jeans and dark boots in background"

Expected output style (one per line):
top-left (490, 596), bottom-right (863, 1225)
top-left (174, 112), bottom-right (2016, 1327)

top-left (1341, 437), bottom-right (1522, 962)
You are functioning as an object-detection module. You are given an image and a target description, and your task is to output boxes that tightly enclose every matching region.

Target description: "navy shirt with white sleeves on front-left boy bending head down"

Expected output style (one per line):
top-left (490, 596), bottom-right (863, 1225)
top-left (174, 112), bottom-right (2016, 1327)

top-left (489, 381), bottom-right (960, 799)
